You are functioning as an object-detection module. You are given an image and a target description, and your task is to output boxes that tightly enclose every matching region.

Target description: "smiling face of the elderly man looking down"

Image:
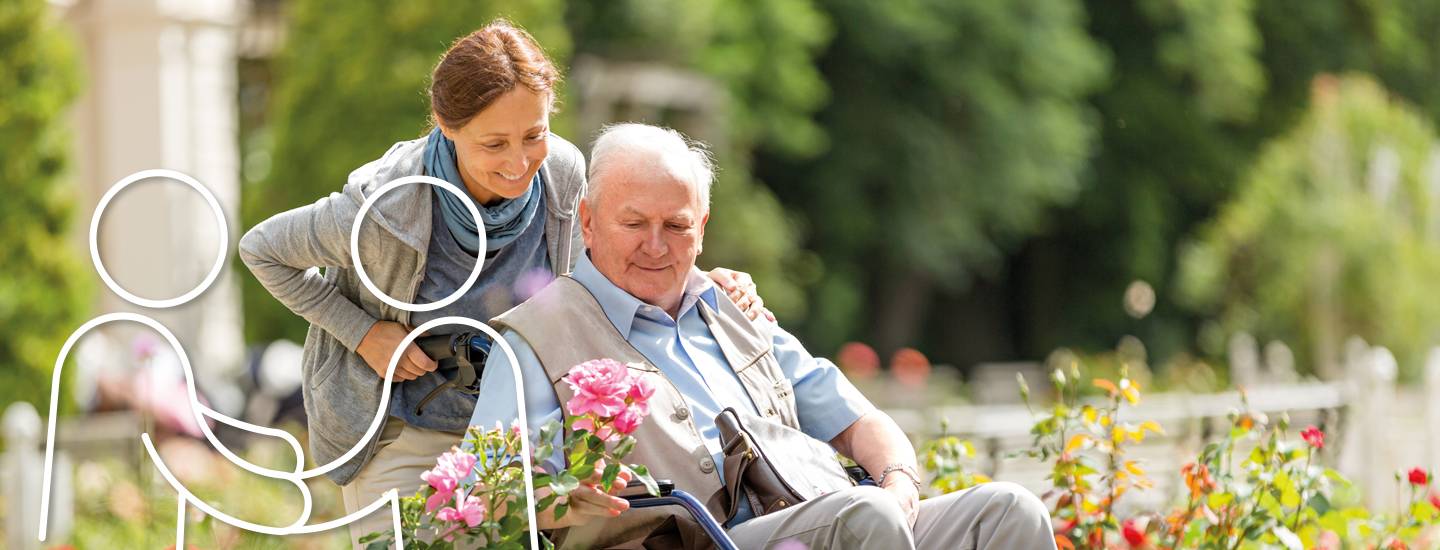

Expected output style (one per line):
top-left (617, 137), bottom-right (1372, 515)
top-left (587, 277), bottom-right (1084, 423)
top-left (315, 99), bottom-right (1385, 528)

top-left (580, 163), bottom-right (710, 315)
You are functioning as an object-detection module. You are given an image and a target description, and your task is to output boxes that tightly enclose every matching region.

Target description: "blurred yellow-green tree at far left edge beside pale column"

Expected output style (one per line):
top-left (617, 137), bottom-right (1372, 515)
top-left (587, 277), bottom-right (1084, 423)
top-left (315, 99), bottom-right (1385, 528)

top-left (0, 0), bottom-right (89, 406)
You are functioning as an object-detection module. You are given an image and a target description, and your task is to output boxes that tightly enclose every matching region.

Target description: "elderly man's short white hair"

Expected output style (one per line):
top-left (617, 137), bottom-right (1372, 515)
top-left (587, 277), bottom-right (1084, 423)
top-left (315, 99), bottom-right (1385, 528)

top-left (585, 122), bottom-right (714, 212)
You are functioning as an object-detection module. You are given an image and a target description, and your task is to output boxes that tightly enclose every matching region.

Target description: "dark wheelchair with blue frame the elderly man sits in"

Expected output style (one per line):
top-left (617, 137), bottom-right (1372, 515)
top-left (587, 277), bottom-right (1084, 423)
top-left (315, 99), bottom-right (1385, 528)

top-left (415, 331), bottom-right (876, 550)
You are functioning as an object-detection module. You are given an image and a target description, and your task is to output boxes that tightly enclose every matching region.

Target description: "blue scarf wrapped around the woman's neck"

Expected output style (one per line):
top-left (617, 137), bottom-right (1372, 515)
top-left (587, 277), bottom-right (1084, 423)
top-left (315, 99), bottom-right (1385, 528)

top-left (425, 127), bottom-right (540, 256)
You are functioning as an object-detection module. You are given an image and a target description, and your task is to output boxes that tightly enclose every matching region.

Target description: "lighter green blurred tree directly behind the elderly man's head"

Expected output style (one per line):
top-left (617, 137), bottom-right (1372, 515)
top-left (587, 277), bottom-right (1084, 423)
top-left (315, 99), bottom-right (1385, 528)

top-left (567, 0), bottom-right (831, 317)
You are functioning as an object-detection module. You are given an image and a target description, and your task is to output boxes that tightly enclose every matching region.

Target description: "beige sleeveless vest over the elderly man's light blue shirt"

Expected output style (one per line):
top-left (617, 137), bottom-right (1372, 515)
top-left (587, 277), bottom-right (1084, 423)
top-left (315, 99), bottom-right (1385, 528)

top-left (491, 276), bottom-right (799, 549)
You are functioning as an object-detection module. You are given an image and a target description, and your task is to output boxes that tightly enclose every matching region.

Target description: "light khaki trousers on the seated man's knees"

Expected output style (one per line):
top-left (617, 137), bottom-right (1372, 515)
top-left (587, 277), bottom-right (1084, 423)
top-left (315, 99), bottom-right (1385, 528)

top-left (730, 482), bottom-right (1056, 550)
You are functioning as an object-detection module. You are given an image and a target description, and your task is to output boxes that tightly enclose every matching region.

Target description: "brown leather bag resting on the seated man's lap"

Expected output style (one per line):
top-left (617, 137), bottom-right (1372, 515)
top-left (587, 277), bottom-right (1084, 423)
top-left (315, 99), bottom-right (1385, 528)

top-left (716, 407), bottom-right (855, 521)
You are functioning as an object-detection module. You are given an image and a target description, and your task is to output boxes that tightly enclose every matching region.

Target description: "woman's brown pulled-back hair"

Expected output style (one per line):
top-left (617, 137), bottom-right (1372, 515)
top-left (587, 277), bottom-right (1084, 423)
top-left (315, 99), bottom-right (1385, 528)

top-left (431, 19), bottom-right (560, 128)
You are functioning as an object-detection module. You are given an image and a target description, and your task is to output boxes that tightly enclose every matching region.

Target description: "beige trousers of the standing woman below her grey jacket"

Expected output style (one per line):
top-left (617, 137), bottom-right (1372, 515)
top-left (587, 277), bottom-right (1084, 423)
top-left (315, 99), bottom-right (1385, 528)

top-left (340, 418), bottom-right (464, 549)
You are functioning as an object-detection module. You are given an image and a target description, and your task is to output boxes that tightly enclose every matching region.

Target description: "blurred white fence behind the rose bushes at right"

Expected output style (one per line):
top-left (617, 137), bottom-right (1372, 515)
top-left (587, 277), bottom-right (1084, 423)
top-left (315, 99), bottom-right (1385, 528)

top-left (887, 344), bottom-right (1440, 510)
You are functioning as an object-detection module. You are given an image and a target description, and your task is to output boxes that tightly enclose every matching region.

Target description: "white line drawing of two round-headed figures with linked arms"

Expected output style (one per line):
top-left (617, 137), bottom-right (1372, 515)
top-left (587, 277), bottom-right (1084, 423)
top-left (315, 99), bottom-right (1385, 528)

top-left (39, 170), bottom-right (539, 550)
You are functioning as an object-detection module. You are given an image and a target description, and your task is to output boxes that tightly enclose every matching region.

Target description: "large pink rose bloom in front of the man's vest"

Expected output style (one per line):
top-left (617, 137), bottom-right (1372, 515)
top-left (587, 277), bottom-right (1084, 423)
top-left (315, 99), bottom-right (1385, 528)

top-left (564, 359), bottom-right (655, 441)
